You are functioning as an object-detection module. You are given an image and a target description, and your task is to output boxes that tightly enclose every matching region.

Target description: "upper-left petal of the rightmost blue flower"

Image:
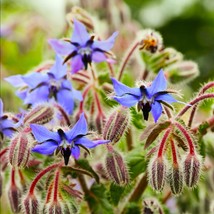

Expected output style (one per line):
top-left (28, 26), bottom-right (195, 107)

top-left (111, 78), bottom-right (142, 96)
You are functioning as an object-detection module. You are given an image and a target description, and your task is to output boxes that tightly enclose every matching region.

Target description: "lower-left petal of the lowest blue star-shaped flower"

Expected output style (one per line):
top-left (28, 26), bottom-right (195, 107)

top-left (32, 140), bottom-right (58, 155)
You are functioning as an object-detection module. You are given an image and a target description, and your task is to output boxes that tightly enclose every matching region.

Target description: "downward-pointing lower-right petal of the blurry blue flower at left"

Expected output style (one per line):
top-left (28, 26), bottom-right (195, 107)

top-left (56, 89), bottom-right (74, 114)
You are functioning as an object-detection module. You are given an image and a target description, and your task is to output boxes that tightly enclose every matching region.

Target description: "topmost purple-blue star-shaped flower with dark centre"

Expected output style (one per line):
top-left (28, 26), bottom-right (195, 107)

top-left (49, 19), bottom-right (118, 73)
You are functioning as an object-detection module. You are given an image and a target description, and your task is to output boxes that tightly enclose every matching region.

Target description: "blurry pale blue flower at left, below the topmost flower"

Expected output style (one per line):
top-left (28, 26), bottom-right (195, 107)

top-left (6, 56), bottom-right (82, 114)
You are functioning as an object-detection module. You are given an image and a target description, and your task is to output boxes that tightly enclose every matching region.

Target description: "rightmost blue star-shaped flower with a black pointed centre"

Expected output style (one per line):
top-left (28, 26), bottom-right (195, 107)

top-left (112, 70), bottom-right (178, 122)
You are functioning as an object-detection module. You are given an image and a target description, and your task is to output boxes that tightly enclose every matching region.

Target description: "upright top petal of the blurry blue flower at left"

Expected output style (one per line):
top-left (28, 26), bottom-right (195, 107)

top-left (49, 55), bottom-right (67, 80)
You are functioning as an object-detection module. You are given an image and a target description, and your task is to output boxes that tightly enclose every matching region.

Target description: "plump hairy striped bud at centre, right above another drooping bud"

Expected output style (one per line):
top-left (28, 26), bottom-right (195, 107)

top-left (103, 106), bottom-right (131, 144)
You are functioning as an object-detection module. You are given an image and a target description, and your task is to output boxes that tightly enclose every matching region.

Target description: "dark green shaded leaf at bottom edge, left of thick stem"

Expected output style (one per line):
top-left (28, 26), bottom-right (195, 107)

top-left (85, 183), bottom-right (114, 214)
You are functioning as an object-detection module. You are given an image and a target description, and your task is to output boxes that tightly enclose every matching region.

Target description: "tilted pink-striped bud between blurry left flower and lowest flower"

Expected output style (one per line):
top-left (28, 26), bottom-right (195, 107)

top-left (24, 105), bottom-right (54, 124)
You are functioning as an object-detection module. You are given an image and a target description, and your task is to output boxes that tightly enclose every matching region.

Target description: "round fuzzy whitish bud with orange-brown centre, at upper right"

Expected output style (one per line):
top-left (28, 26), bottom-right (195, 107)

top-left (138, 29), bottom-right (163, 53)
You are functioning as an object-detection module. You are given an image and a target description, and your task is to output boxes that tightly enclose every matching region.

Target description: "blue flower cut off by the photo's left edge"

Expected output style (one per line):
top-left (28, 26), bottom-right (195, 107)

top-left (0, 99), bottom-right (15, 138)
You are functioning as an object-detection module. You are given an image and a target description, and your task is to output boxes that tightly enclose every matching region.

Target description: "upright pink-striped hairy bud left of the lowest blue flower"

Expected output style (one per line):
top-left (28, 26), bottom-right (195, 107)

top-left (9, 132), bottom-right (30, 167)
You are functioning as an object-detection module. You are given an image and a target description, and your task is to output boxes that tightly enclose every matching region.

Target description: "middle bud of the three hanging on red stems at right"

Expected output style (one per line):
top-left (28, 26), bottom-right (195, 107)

top-left (168, 165), bottom-right (184, 195)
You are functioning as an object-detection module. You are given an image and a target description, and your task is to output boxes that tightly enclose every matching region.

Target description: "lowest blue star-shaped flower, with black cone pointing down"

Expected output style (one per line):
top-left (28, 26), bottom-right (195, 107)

top-left (30, 113), bottom-right (110, 165)
